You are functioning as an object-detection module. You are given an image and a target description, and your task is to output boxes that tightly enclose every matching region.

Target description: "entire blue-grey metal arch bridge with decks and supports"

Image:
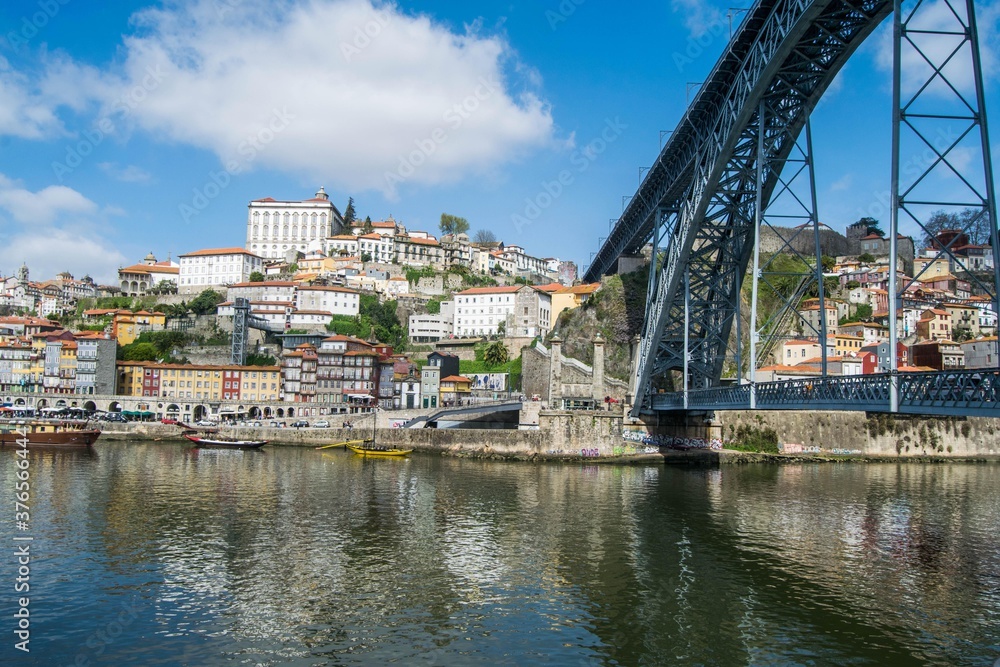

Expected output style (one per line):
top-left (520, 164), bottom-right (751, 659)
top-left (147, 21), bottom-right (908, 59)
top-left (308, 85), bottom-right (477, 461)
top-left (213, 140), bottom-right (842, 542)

top-left (585, 0), bottom-right (1000, 415)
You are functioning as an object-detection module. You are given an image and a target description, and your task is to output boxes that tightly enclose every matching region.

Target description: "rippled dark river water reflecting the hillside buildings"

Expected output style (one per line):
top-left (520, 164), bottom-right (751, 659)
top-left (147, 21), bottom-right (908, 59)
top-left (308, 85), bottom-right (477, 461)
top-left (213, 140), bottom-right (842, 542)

top-left (0, 442), bottom-right (1000, 666)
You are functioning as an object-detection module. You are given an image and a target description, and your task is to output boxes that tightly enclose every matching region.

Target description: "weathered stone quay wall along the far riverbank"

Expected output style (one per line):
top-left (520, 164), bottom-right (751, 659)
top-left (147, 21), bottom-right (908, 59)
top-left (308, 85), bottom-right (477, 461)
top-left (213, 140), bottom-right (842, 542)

top-left (98, 410), bottom-right (1000, 462)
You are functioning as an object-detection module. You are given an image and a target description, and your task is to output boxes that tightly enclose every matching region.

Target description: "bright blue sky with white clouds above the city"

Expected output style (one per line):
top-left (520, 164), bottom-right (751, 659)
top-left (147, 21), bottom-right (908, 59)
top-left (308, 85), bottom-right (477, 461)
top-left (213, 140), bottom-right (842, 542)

top-left (0, 0), bottom-right (1000, 284)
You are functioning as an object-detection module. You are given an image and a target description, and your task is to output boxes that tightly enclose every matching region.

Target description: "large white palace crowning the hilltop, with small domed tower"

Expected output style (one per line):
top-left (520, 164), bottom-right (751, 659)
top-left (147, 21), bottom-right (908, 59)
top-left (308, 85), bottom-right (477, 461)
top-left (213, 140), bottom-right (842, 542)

top-left (246, 188), bottom-right (344, 259)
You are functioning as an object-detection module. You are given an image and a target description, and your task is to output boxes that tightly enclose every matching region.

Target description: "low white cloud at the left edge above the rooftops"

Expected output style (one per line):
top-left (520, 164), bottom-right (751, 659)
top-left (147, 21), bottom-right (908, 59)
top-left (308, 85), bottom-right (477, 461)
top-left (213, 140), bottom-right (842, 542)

top-left (0, 174), bottom-right (127, 284)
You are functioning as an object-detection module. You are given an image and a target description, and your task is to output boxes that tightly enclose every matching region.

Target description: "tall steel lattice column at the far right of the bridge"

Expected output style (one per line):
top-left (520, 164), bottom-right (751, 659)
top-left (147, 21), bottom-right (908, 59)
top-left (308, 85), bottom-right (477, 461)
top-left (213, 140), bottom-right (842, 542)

top-left (889, 0), bottom-right (1000, 412)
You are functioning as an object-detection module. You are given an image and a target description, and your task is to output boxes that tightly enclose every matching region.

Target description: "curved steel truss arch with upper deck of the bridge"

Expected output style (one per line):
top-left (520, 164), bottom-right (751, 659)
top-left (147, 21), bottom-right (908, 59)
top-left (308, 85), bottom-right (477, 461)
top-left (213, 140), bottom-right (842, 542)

top-left (585, 0), bottom-right (988, 414)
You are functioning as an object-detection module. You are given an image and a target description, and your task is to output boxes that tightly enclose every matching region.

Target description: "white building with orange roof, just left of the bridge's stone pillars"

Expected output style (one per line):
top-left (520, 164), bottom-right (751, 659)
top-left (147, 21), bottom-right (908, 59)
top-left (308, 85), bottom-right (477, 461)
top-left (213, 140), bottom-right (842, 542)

top-left (455, 285), bottom-right (552, 338)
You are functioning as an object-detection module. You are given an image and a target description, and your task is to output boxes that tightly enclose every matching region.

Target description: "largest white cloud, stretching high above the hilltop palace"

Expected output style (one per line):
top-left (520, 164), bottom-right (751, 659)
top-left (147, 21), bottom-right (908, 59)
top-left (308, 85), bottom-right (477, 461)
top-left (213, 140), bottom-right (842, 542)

top-left (39, 0), bottom-right (555, 195)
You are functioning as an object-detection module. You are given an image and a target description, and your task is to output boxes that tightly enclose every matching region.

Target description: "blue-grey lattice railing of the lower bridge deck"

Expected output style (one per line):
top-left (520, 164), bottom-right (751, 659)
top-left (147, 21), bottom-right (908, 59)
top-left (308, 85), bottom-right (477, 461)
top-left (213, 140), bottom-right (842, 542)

top-left (652, 370), bottom-right (1000, 416)
